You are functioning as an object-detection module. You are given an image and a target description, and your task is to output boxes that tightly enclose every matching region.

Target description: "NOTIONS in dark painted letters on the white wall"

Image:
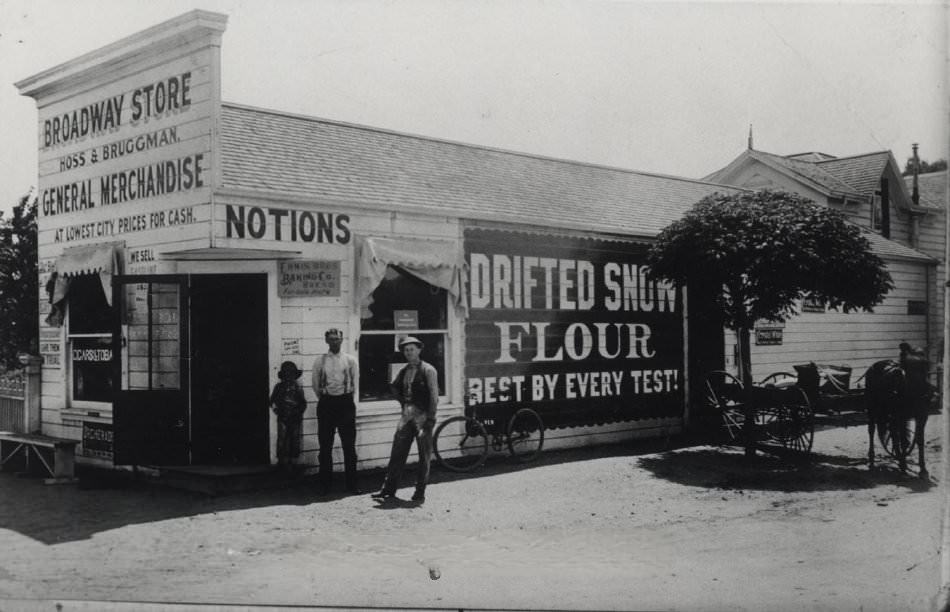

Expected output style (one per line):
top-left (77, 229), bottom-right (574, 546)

top-left (225, 204), bottom-right (352, 244)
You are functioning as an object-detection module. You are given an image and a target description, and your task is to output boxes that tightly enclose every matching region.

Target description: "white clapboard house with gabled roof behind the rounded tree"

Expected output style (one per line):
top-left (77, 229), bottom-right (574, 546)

top-left (703, 142), bottom-right (946, 379)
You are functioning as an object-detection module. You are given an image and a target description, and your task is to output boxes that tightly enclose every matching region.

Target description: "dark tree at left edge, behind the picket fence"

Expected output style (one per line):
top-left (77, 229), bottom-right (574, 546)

top-left (0, 194), bottom-right (39, 368)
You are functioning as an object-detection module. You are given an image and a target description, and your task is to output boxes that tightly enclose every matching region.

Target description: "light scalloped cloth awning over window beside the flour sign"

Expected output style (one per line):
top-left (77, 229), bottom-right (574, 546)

top-left (355, 238), bottom-right (468, 314)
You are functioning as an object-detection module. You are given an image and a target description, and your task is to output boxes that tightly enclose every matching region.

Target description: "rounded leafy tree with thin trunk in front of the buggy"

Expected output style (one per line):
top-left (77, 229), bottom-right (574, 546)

top-left (647, 190), bottom-right (893, 455)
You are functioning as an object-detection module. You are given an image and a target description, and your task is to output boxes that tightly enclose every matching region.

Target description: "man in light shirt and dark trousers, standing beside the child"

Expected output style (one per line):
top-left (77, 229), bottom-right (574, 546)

top-left (313, 329), bottom-right (360, 495)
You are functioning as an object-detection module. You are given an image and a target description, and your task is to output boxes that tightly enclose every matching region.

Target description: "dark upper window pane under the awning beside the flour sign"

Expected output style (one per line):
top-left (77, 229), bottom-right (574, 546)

top-left (361, 266), bottom-right (448, 330)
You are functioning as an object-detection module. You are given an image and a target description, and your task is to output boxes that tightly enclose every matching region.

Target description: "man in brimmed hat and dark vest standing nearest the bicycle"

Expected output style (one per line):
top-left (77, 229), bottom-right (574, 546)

top-left (373, 336), bottom-right (439, 503)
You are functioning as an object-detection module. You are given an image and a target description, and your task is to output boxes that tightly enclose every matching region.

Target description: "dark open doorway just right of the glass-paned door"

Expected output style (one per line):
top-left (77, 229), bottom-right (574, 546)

top-left (189, 274), bottom-right (270, 465)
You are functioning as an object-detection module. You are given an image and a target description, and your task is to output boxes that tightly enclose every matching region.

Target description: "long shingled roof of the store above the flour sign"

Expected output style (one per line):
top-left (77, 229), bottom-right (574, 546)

top-left (221, 104), bottom-right (742, 236)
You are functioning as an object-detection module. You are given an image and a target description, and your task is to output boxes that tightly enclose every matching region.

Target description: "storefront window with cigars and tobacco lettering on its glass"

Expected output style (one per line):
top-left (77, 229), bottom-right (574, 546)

top-left (67, 274), bottom-right (113, 402)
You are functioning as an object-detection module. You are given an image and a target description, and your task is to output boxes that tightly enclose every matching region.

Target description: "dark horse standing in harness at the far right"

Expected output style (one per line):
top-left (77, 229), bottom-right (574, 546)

top-left (864, 355), bottom-right (930, 479)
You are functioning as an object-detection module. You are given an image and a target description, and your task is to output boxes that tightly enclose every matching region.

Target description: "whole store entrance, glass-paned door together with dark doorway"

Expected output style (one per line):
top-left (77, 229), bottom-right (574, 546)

top-left (113, 274), bottom-right (270, 465)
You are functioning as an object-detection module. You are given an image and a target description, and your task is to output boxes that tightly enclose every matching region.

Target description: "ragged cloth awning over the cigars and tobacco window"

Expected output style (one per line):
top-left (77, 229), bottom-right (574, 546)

top-left (46, 242), bottom-right (124, 327)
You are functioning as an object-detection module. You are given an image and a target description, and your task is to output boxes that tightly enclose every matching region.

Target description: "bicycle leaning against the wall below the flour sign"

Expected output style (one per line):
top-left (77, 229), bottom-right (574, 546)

top-left (433, 396), bottom-right (544, 472)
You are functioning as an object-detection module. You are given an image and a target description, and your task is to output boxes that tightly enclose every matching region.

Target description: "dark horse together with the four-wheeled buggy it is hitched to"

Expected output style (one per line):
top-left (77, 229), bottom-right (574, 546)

top-left (705, 351), bottom-right (935, 478)
